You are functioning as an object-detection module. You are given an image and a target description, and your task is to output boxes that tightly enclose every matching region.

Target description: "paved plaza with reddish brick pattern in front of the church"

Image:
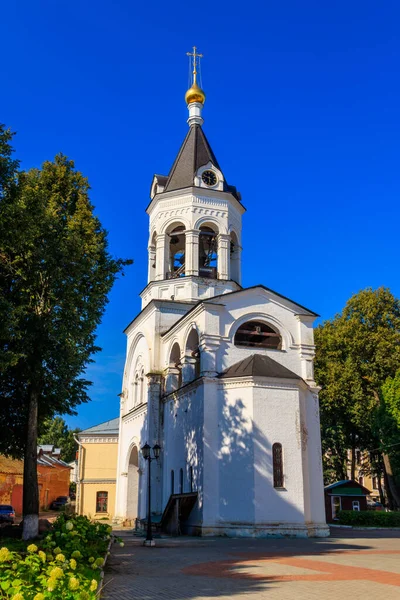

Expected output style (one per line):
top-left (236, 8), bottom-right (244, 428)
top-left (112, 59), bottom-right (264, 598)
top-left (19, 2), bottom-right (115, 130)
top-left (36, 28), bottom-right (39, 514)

top-left (102, 530), bottom-right (400, 600)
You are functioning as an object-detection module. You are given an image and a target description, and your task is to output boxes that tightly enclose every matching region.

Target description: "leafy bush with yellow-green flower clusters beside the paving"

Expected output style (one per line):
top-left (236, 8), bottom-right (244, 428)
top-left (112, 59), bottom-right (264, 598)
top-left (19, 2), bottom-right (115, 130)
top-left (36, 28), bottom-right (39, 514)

top-left (0, 514), bottom-right (118, 600)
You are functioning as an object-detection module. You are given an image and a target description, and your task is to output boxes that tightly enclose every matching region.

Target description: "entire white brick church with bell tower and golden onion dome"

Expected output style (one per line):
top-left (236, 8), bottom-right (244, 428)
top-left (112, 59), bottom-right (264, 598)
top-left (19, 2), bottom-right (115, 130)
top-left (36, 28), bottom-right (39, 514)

top-left (116, 49), bottom-right (328, 536)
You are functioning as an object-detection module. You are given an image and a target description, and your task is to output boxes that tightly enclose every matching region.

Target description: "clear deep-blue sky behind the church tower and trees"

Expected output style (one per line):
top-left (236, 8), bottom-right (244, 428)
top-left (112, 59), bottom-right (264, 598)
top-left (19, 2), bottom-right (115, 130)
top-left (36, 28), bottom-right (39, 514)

top-left (0, 0), bottom-right (400, 428)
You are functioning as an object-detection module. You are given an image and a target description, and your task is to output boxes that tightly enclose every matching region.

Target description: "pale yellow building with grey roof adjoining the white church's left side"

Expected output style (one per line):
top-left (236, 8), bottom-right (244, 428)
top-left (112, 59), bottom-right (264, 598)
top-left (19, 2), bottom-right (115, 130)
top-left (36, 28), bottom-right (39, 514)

top-left (76, 418), bottom-right (119, 519)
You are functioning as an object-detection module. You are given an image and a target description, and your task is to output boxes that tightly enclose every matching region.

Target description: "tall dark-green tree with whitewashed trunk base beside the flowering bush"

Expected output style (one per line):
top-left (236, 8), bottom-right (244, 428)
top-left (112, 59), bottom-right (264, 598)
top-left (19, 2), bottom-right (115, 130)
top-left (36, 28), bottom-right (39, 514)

top-left (0, 135), bottom-right (129, 539)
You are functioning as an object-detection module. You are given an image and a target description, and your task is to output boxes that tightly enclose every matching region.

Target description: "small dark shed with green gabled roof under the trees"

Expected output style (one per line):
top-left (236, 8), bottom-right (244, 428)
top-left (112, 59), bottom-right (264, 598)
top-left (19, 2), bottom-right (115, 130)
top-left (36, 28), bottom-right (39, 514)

top-left (325, 479), bottom-right (371, 523)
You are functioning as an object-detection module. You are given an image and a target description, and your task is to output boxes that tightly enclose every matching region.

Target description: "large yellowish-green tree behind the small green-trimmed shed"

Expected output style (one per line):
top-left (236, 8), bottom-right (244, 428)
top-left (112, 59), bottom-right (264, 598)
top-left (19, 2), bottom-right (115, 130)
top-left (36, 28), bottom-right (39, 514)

top-left (315, 288), bottom-right (400, 504)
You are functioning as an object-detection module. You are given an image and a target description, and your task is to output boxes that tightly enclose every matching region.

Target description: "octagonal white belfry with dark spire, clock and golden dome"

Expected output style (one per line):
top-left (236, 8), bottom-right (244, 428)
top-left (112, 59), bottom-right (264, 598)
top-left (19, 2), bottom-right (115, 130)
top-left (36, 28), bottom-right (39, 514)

top-left (141, 47), bottom-right (245, 308)
